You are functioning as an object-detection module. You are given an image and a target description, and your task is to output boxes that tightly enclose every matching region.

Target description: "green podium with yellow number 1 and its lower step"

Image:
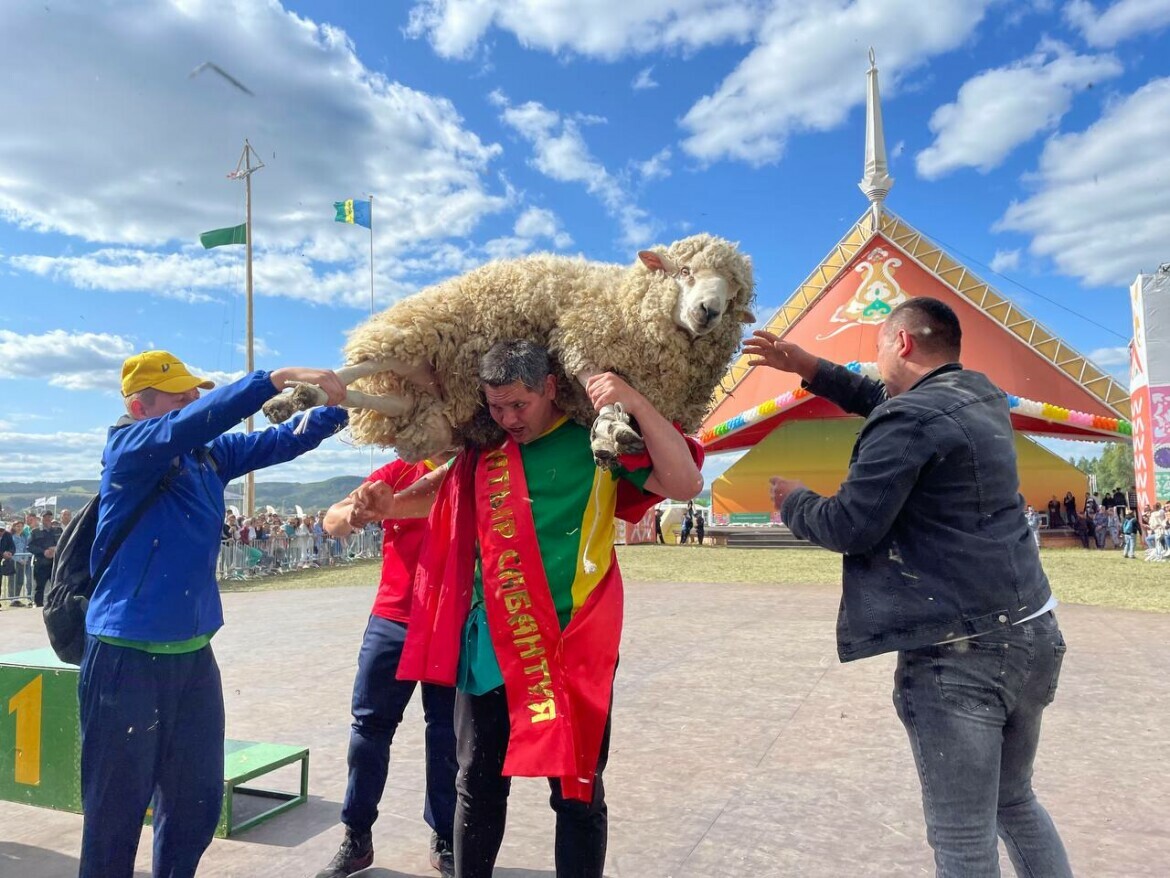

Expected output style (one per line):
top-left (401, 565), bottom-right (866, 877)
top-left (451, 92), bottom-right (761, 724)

top-left (0, 649), bottom-right (309, 838)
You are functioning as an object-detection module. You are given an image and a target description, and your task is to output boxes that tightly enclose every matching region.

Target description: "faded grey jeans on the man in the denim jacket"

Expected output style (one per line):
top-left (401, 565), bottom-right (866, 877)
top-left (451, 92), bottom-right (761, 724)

top-left (894, 612), bottom-right (1072, 878)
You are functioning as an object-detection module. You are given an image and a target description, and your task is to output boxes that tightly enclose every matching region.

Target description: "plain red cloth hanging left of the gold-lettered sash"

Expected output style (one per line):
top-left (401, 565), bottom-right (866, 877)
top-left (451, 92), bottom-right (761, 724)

top-left (398, 452), bottom-right (476, 686)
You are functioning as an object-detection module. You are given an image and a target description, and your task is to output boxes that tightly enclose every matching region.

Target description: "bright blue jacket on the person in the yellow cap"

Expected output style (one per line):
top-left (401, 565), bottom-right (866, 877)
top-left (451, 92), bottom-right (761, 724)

top-left (85, 372), bottom-right (347, 643)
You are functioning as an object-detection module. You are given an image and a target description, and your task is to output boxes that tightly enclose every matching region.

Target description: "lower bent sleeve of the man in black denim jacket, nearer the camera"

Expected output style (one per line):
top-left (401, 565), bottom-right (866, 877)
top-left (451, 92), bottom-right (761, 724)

top-left (780, 411), bottom-right (931, 555)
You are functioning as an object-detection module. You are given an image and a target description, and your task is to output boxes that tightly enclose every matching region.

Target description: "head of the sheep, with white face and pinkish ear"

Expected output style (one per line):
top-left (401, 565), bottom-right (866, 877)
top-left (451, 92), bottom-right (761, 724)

top-left (638, 234), bottom-right (756, 338)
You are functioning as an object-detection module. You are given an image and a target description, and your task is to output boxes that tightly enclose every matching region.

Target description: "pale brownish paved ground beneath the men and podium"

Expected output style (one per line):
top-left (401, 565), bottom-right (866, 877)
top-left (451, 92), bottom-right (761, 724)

top-left (0, 583), bottom-right (1170, 878)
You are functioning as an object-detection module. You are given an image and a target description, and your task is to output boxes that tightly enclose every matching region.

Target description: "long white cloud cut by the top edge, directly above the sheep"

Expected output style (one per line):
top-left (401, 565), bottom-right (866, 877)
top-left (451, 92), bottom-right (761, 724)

top-left (406, 0), bottom-right (766, 61)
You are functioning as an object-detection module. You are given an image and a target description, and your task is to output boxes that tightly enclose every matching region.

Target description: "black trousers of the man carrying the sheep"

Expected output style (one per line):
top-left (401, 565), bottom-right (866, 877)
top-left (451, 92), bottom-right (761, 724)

top-left (455, 686), bottom-right (612, 878)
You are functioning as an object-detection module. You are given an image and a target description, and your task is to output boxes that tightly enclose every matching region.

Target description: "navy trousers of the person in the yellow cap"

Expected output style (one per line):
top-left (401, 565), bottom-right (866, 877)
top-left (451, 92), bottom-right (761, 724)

top-left (77, 637), bottom-right (223, 878)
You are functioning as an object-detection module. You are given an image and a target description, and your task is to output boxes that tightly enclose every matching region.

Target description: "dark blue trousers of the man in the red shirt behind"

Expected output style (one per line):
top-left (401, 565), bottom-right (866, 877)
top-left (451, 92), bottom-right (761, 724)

top-left (342, 616), bottom-right (459, 844)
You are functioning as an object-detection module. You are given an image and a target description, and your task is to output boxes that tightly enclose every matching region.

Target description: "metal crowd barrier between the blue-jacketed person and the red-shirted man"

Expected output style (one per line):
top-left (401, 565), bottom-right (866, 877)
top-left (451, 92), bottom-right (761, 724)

top-left (215, 527), bottom-right (383, 581)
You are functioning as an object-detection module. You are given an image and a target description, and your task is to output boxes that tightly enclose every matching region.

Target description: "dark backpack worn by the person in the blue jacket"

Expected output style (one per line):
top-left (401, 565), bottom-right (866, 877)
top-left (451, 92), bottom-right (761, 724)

top-left (44, 455), bottom-right (182, 665)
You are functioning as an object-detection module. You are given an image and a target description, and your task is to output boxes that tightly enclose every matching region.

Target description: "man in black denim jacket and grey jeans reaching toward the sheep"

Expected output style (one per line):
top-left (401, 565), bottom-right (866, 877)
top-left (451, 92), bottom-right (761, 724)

top-left (744, 297), bottom-right (1072, 878)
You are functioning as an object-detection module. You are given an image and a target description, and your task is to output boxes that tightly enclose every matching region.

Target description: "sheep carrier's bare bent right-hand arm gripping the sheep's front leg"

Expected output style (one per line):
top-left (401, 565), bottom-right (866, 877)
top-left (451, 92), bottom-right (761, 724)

top-left (585, 372), bottom-right (703, 500)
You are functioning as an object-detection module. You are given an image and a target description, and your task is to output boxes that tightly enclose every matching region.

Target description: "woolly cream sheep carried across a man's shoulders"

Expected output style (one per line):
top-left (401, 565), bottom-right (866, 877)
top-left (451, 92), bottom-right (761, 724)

top-left (264, 234), bottom-right (755, 467)
